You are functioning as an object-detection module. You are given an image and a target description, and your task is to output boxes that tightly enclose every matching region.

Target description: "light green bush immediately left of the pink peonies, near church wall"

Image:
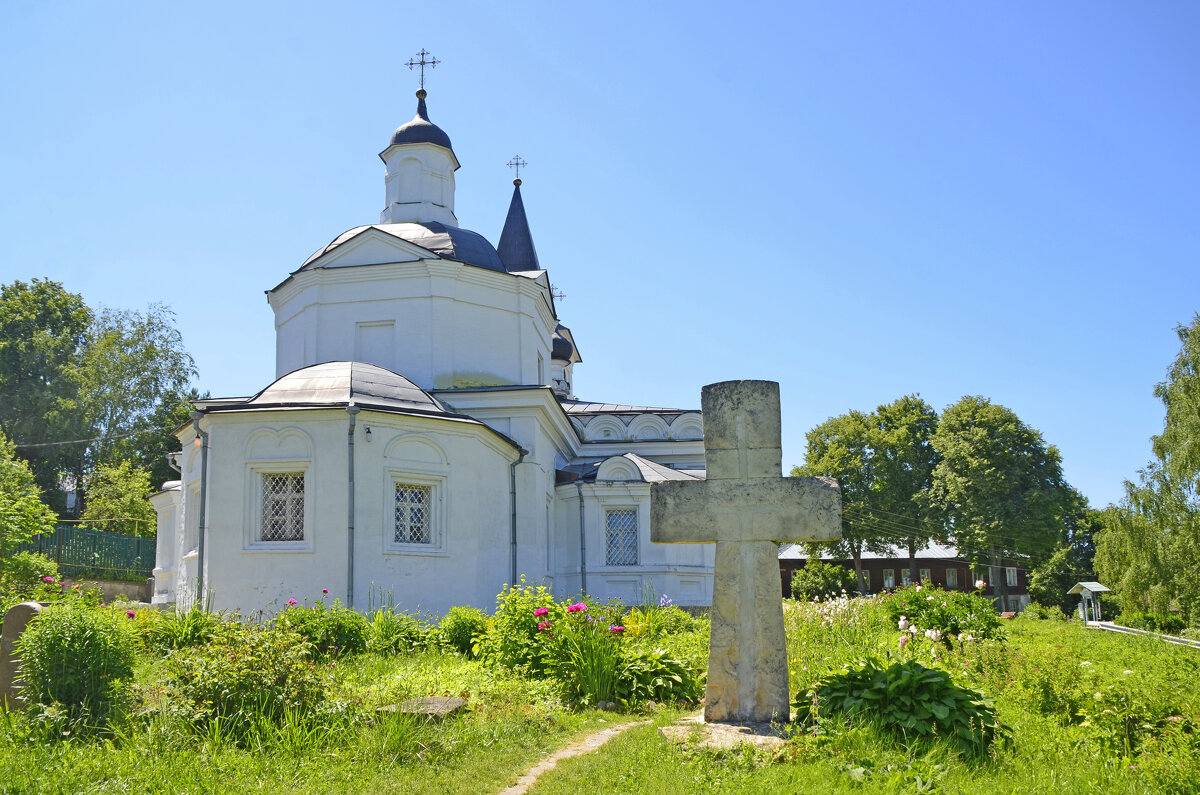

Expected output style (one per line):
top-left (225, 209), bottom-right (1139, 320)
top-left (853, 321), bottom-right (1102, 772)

top-left (475, 575), bottom-right (560, 674)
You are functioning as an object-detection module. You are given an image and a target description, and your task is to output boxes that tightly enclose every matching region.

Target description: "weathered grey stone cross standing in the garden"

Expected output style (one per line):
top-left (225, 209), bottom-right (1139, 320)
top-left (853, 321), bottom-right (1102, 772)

top-left (650, 381), bottom-right (841, 723)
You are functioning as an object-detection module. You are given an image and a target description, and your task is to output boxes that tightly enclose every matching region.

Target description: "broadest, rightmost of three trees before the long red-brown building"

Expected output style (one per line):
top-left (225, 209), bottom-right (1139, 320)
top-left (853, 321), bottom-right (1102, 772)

top-left (926, 396), bottom-right (1070, 610)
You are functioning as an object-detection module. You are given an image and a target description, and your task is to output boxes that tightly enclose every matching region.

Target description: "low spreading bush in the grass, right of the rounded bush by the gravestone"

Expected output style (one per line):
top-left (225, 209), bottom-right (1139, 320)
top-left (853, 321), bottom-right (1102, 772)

top-left (164, 621), bottom-right (331, 739)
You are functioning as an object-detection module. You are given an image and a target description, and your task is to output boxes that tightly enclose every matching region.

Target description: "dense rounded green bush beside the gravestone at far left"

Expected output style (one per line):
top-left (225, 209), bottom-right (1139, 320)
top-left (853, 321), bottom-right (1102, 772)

top-left (18, 604), bottom-right (137, 728)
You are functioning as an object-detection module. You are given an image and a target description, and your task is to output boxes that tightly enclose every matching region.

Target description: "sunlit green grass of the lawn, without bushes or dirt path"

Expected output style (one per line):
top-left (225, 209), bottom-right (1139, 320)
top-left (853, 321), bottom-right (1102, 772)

top-left (0, 594), bottom-right (1200, 794)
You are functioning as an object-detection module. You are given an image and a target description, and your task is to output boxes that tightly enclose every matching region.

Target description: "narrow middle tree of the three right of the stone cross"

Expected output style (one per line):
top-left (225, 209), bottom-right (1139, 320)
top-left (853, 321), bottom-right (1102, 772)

top-left (870, 395), bottom-right (938, 582)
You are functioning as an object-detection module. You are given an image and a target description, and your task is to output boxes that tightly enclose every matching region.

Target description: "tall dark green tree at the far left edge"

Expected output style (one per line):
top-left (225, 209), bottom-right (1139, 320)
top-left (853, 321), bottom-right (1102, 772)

top-left (0, 279), bottom-right (92, 509)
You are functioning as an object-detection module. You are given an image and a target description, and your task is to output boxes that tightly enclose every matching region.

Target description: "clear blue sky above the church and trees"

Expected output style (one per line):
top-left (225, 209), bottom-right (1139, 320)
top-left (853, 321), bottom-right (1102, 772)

top-left (0, 0), bottom-right (1200, 506)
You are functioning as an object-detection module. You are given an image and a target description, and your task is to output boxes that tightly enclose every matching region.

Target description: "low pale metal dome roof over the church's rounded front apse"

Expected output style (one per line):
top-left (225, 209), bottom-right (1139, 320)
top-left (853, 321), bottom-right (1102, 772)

top-left (241, 361), bottom-right (457, 417)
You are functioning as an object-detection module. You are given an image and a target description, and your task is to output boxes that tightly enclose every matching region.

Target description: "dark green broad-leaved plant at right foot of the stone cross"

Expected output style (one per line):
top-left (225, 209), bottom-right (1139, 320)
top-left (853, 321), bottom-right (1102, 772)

top-left (796, 660), bottom-right (1009, 757)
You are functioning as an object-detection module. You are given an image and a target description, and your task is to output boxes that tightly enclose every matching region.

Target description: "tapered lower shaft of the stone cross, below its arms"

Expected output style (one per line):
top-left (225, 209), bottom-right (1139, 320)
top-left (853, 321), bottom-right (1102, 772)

top-left (704, 540), bottom-right (791, 723)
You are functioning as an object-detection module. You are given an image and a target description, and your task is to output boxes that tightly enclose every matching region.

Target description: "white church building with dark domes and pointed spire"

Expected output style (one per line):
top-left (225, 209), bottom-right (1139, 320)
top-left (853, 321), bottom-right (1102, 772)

top-left (151, 82), bottom-right (714, 614)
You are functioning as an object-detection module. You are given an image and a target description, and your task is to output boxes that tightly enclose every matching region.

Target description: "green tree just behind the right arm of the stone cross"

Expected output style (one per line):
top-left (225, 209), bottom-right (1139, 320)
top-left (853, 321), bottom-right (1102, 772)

top-left (792, 411), bottom-right (887, 591)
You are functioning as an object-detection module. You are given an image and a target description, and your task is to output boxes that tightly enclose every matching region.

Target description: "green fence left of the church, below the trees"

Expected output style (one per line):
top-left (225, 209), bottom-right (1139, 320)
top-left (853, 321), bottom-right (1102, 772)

top-left (20, 525), bottom-right (155, 580)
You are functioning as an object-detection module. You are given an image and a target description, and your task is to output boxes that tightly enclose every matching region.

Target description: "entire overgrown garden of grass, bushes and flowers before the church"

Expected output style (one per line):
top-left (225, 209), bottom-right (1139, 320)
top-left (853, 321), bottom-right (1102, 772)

top-left (0, 585), bottom-right (1200, 793)
